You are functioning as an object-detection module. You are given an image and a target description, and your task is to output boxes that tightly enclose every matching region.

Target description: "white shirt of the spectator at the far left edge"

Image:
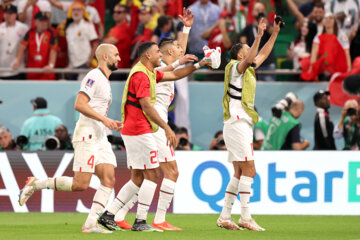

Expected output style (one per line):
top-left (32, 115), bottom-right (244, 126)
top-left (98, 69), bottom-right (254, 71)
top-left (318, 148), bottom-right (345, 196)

top-left (0, 21), bottom-right (29, 77)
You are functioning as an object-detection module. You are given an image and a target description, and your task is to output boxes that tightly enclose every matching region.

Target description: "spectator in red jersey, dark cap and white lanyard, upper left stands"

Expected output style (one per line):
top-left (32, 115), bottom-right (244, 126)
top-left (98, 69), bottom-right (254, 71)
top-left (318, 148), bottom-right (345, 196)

top-left (13, 12), bottom-right (58, 80)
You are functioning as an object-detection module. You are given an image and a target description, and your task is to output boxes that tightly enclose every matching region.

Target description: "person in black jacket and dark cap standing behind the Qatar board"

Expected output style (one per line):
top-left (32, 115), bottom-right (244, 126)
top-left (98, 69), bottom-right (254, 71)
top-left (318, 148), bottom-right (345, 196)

top-left (314, 90), bottom-right (336, 150)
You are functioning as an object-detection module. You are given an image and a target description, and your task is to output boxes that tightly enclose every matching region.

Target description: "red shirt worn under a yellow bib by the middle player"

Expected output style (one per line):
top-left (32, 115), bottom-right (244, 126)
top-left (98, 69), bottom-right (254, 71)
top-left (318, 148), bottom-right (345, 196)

top-left (121, 71), bottom-right (164, 136)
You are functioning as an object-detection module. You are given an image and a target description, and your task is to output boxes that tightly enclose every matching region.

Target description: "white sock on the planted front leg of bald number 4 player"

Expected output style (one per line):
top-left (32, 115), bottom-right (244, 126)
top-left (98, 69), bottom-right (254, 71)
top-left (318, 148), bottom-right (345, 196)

top-left (85, 185), bottom-right (112, 226)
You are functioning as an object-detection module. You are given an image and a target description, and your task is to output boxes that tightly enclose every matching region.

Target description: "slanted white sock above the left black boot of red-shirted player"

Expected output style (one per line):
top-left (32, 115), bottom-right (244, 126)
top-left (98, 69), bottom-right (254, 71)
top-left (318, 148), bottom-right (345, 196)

top-left (108, 180), bottom-right (139, 215)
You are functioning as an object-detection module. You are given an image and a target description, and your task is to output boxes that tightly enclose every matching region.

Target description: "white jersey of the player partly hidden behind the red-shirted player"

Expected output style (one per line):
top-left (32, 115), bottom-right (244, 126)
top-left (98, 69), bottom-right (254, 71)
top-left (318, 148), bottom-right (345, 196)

top-left (154, 61), bottom-right (175, 122)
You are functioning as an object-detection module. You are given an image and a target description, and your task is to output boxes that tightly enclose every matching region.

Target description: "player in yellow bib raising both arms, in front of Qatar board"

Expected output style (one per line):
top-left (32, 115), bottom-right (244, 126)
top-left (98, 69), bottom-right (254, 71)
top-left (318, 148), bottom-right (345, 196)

top-left (216, 16), bottom-right (281, 231)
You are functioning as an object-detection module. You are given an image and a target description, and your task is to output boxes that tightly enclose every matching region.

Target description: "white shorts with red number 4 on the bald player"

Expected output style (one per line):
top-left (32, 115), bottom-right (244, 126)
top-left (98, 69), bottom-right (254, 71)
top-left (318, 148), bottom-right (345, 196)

top-left (73, 136), bottom-right (116, 173)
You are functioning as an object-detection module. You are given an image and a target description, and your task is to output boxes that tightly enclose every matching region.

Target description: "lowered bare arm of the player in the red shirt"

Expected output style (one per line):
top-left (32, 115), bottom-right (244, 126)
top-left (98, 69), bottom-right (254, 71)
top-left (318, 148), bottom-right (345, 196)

top-left (139, 97), bottom-right (176, 147)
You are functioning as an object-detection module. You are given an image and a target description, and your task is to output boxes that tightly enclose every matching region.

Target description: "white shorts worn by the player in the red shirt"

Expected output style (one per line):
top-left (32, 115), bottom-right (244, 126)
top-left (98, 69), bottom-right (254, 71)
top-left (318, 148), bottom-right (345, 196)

top-left (122, 133), bottom-right (159, 170)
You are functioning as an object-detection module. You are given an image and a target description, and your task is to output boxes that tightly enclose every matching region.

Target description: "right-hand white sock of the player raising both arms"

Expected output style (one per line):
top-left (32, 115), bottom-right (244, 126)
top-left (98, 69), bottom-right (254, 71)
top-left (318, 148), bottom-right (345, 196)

top-left (239, 176), bottom-right (253, 219)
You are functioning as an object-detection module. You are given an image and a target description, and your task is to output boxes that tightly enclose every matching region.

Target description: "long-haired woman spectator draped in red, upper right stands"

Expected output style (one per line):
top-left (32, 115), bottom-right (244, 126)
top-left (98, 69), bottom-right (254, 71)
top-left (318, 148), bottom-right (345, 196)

top-left (301, 13), bottom-right (351, 81)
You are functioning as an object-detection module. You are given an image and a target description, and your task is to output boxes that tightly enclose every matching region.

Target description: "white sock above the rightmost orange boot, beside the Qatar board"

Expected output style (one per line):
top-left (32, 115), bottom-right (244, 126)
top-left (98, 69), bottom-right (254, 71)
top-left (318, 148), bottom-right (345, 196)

top-left (154, 178), bottom-right (176, 223)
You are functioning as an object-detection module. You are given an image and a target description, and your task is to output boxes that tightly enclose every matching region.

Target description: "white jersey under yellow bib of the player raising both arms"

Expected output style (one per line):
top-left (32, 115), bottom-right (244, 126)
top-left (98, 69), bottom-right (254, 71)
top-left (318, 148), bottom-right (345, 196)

top-left (225, 63), bottom-right (256, 124)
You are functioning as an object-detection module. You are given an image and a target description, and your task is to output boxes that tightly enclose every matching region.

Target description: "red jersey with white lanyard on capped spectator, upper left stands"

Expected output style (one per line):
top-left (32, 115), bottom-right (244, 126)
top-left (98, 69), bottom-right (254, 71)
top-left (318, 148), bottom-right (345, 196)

top-left (21, 28), bottom-right (58, 80)
